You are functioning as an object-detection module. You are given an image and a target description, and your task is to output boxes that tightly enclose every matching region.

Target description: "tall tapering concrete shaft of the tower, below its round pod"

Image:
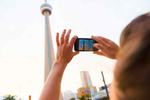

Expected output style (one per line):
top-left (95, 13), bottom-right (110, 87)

top-left (44, 11), bottom-right (55, 82)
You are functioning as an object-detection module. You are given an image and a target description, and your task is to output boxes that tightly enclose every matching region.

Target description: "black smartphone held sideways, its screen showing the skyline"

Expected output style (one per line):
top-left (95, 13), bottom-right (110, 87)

top-left (74, 38), bottom-right (98, 51)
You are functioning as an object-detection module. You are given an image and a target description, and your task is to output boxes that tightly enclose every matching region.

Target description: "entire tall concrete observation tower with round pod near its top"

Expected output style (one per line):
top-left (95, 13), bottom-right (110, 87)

top-left (41, 0), bottom-right (63, 100)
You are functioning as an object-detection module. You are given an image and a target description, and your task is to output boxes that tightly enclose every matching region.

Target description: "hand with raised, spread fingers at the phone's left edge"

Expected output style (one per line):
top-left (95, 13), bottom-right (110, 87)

top-left (56, 29), bottom-right (79, 64)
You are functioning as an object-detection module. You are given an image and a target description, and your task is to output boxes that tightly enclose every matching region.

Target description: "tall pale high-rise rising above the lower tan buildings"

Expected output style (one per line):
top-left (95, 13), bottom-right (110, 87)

top-left (80, 71), bottom-right (92, 87)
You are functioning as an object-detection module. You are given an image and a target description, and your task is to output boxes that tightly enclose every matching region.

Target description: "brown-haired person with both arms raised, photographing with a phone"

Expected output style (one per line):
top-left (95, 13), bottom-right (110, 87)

top-left (39, 13), bottom-right (150, 100)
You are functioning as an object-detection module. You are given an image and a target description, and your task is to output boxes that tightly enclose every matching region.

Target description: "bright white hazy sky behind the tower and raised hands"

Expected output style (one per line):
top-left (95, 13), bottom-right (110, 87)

top-left (0, 0), bottom-right (150, 100)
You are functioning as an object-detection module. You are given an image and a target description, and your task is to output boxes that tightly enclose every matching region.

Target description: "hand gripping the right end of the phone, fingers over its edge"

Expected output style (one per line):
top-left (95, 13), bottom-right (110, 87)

top-left (92, 36), bottom-right (119, 59)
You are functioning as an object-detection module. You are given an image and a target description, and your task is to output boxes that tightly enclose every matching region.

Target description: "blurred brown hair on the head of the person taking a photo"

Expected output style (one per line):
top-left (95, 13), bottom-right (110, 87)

top-left (114, 13), bottom-right (150, 100)
